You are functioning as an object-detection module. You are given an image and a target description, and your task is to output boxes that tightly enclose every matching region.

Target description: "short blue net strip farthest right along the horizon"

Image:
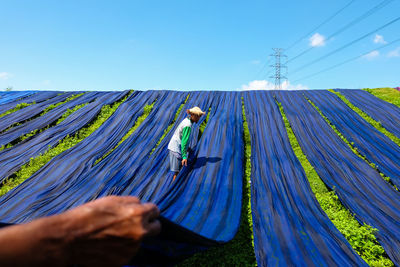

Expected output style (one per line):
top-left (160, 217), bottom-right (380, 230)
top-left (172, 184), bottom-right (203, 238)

top-left (336, 89), bottom-right (400, 138)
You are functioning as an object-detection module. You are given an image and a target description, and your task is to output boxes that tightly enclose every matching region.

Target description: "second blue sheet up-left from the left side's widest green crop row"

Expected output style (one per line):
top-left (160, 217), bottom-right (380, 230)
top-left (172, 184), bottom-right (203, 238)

top-left (0, 92), bottom-right (106, 146)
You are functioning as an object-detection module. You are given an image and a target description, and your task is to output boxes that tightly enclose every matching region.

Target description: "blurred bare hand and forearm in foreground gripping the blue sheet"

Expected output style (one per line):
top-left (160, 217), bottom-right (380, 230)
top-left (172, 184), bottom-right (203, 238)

top-left (0, 196), bottom-right (161, 266)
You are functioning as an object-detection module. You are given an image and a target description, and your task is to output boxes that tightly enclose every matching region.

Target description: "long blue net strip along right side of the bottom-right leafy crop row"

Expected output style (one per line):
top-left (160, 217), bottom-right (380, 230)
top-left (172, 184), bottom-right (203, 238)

top-left (276, 92), bottom-right (400, 265)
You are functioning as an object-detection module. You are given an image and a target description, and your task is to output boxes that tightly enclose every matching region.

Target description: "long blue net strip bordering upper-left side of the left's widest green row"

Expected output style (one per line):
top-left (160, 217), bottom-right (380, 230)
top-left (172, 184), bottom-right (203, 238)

top-left (0, 92), bottom-right (126, 181)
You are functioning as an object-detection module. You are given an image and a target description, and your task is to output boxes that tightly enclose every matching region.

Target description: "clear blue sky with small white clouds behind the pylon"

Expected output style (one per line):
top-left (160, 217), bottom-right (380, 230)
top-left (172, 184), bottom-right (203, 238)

top-left (0, 0), bottom-right (400, 91)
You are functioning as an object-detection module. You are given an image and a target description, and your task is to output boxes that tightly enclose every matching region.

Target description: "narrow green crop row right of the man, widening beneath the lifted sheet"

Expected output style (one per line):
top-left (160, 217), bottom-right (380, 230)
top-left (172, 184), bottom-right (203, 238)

top-left (178, 99), bottom-right (257, 266)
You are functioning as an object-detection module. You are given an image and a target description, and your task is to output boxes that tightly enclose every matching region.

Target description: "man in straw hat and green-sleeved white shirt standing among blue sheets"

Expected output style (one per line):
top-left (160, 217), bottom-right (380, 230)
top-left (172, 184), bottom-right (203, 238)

top-left (168, 107), bottom-right (205, 181)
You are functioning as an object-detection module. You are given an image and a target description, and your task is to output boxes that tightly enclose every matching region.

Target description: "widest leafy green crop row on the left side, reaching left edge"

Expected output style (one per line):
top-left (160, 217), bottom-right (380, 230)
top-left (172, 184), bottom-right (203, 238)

top-left (0, 95), bottom-right (129, 196)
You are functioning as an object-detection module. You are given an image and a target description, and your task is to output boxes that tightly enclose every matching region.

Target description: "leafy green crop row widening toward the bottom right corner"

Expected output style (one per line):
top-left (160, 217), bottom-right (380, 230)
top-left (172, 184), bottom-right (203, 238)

top-left (277, 99), bottom-right (393, 266)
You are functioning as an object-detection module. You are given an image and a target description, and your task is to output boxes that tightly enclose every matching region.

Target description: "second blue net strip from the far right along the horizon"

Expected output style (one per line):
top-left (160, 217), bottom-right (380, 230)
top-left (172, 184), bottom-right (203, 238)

top-left (304, 91), bottom-right (400, 188)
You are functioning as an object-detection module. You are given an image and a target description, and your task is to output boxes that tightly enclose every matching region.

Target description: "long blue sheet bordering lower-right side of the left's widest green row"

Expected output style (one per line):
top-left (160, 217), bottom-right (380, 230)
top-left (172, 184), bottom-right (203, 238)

top-left (0, 91), bottom-right (162, 223)
